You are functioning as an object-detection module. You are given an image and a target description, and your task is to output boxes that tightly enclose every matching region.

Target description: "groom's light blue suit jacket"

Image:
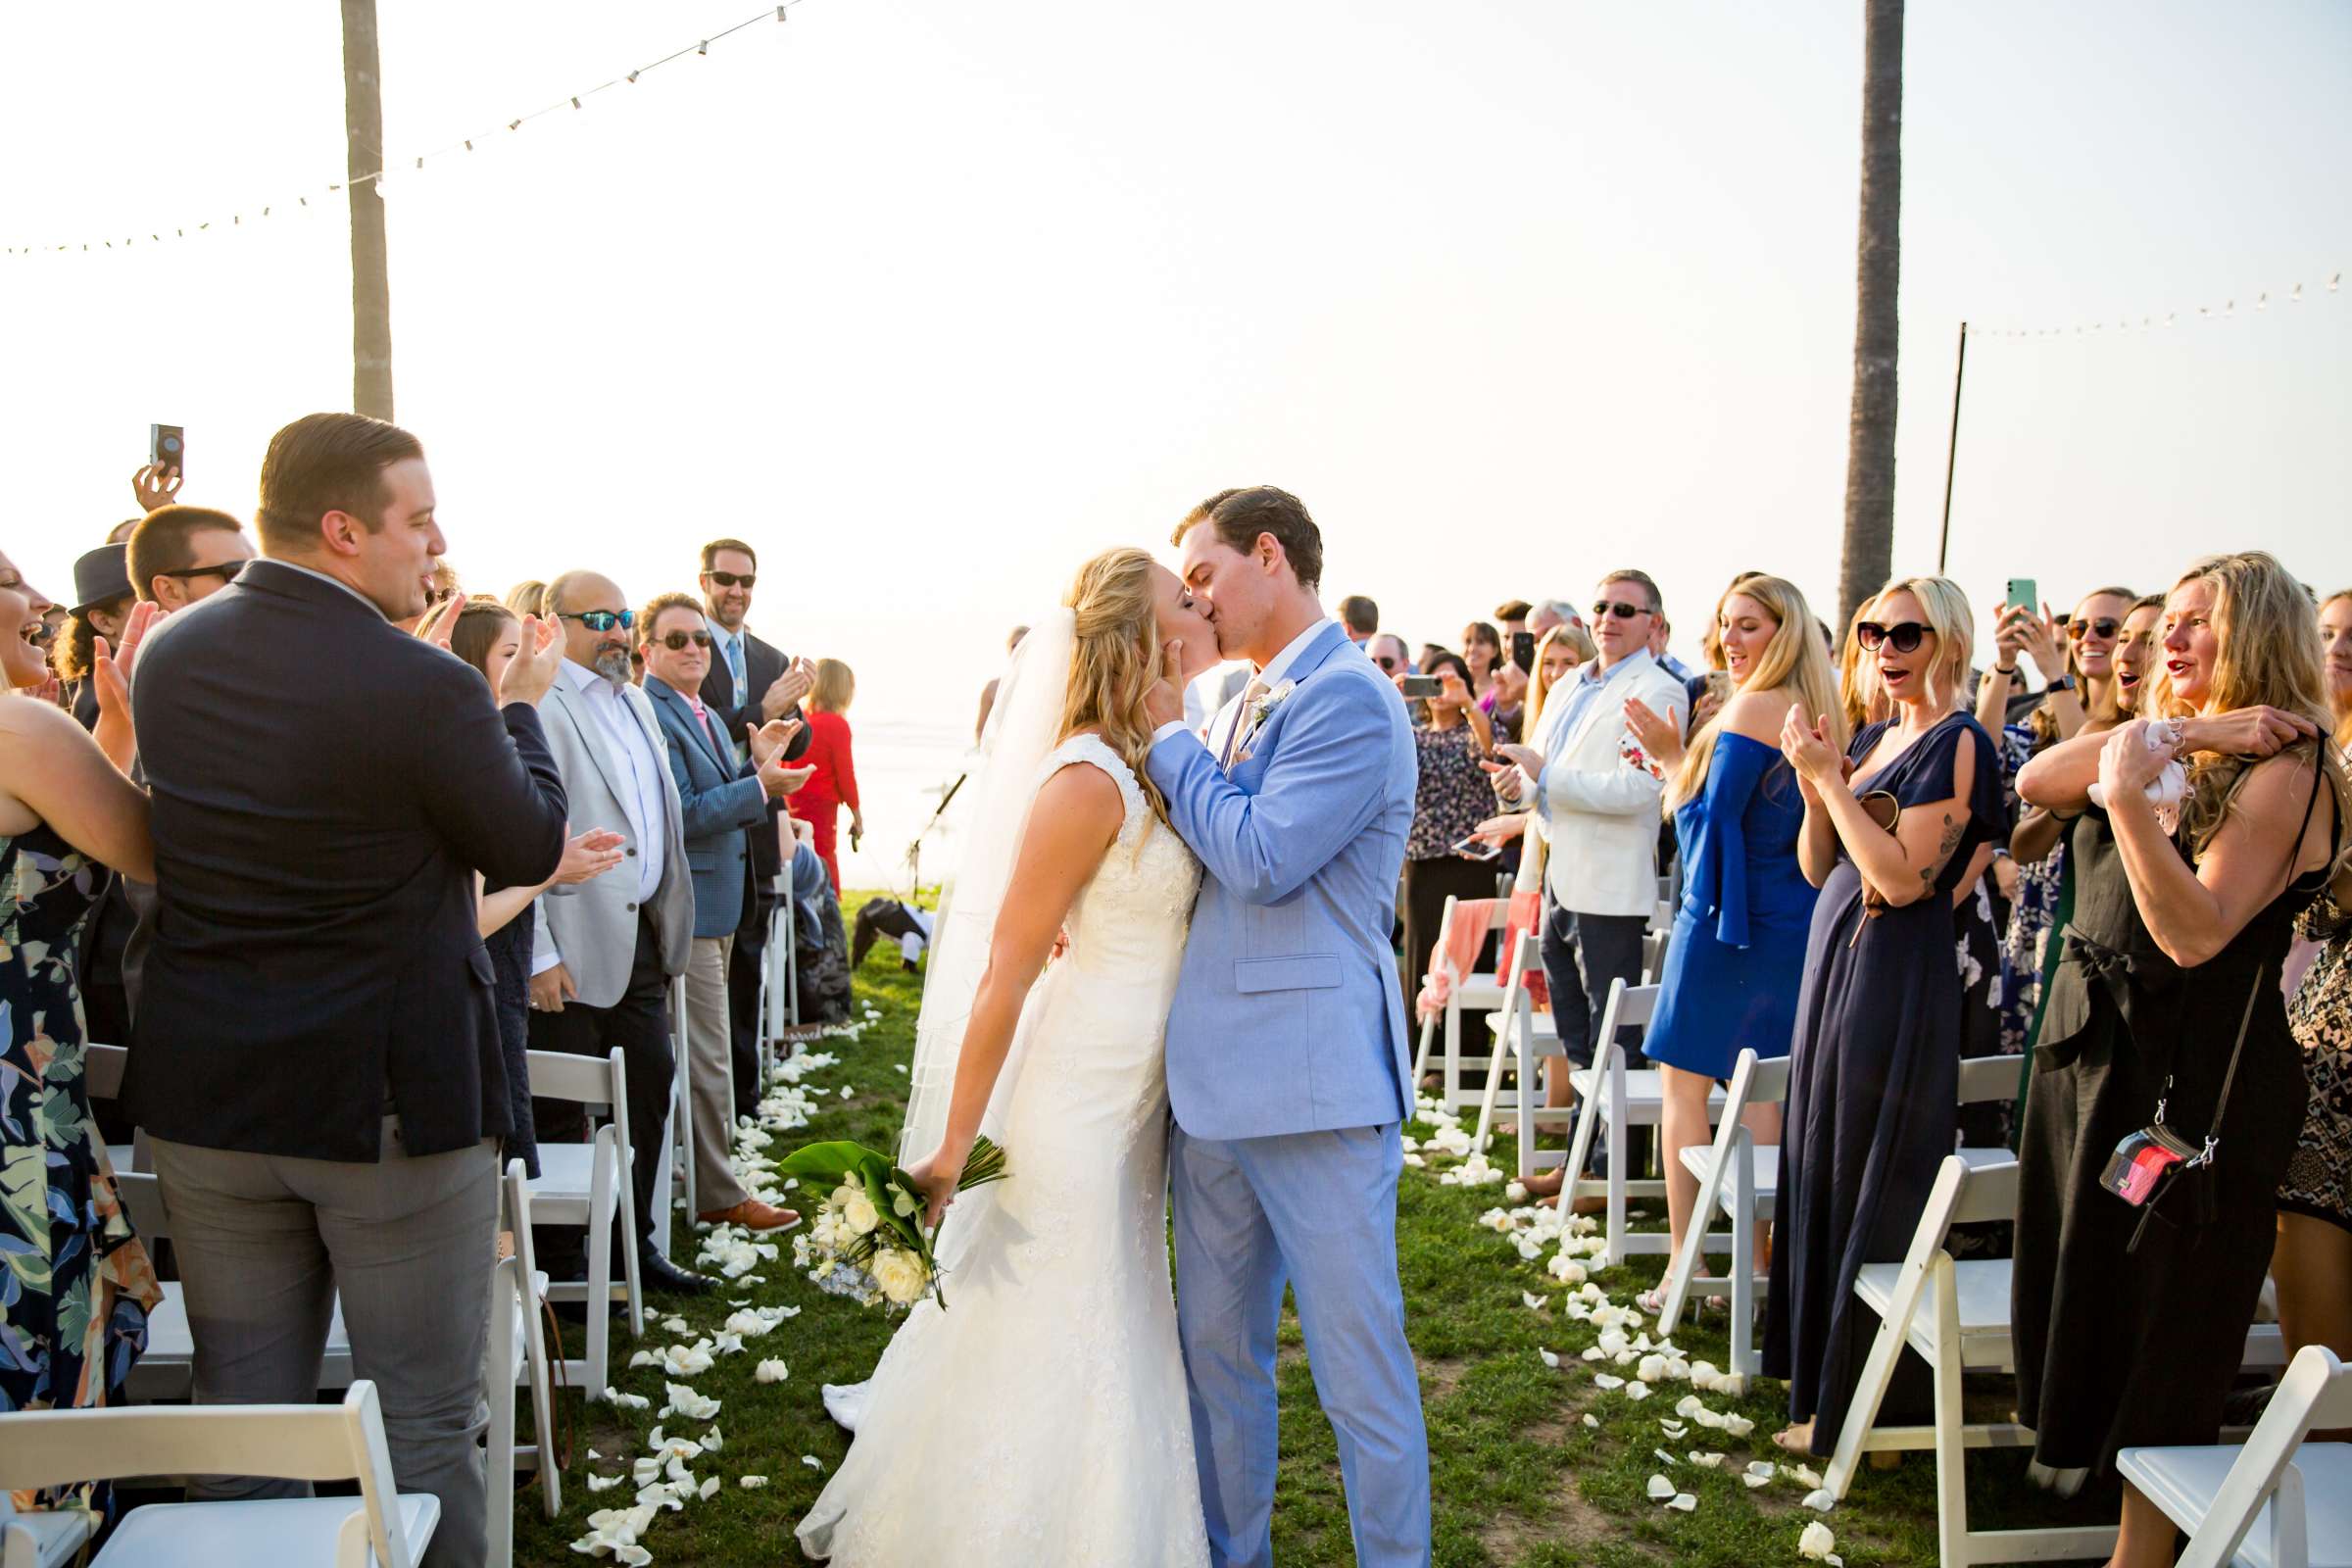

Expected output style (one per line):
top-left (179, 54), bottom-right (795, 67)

top-left (1148, 623), bottom-right (1421, 1140)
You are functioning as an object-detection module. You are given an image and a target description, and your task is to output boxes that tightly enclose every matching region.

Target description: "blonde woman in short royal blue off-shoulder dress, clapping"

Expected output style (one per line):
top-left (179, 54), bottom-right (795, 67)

top-left (1625, 573), bottom-right (1846, 1312)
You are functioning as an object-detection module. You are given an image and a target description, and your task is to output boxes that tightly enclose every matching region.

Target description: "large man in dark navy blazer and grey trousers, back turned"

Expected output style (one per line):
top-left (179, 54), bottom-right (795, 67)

top-left (127, 414), bottom-right (566, 1568)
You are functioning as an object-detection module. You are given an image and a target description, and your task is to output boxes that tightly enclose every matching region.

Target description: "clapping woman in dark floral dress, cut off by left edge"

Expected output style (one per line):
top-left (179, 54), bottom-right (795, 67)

top-left (0, 555), bottom-right (163, 1511)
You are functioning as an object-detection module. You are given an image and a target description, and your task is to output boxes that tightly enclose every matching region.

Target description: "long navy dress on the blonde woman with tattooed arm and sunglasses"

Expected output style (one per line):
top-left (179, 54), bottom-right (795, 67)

top-left (1764, 712), bottom-right (2004, 1455)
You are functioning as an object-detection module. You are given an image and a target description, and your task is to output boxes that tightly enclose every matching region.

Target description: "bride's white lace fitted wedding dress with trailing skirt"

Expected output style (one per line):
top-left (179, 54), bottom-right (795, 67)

top-left (798, 736), bottom-right (1209, 1568)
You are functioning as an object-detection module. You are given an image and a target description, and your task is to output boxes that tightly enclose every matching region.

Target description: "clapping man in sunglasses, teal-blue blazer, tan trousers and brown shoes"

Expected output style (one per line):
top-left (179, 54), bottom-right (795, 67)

top-left (637, 592), bottom-right (816, 1230)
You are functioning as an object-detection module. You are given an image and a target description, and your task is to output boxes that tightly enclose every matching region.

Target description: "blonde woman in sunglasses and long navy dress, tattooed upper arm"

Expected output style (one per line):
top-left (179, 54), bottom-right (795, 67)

top-left (1764, 578), bottom-right (2009, 1452)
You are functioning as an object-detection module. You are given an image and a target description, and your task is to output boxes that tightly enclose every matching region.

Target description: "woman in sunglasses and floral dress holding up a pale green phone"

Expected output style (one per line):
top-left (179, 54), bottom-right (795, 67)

top-left (1976, 588), bottom-right (2162, 1055)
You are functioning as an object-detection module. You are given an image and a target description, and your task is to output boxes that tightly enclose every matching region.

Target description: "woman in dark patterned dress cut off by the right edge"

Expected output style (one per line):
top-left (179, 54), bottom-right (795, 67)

top-left (2270, 588), bottom-right (2352, 1441)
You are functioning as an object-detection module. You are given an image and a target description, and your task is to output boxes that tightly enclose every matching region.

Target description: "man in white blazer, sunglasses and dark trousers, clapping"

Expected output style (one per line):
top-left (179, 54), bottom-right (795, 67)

top-left (1505, 569), bottom-right (1691, 1170)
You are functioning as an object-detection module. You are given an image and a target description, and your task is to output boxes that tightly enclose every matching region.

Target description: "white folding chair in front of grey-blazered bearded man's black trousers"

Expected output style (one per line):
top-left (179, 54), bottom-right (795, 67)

top-left (527, 1046), bottom-right (645, 1398)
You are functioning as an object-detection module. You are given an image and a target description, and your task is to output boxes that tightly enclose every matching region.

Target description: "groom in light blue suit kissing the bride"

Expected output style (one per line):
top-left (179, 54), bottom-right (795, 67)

top-left (1148, 484), bottom-right (1430, 1568)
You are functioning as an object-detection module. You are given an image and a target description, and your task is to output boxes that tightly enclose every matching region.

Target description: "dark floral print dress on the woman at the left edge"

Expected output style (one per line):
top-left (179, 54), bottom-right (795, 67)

top-left (0, 827), bottom-right (163, 1507)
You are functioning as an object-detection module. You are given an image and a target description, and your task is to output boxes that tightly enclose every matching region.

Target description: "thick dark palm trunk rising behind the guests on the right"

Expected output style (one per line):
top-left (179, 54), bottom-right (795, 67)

top-left (1837, 0), bottom-right (1903, 625)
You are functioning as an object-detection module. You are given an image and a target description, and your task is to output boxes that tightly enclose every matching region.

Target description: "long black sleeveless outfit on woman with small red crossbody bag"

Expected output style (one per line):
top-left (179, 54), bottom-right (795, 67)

top-left (2011, 766), bottom-right (2327, 1469)
